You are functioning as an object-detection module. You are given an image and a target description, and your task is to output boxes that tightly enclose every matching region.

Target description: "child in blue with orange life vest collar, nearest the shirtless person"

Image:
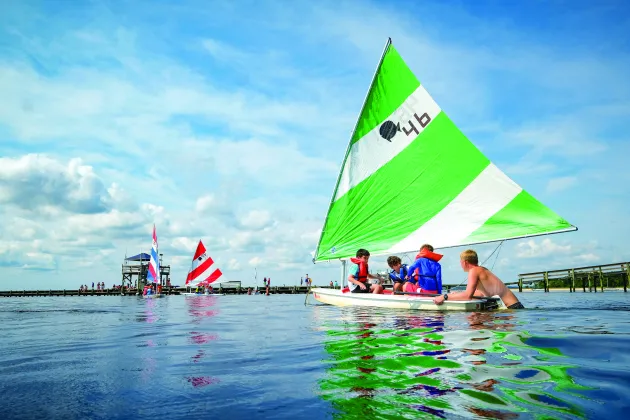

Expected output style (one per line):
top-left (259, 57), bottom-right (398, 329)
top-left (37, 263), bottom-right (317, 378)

top-left (403, 244), bottom-right (442, 294)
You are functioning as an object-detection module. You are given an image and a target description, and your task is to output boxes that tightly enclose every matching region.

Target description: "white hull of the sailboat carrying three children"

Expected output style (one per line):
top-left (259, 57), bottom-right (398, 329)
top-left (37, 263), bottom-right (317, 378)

top-left (311, 287), bottom-right (506, 311)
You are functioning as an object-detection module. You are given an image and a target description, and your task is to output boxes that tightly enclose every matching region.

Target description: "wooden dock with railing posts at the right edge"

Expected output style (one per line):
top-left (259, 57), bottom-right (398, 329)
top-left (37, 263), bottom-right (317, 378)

top-left (518, 262), bottom-right (630, 293)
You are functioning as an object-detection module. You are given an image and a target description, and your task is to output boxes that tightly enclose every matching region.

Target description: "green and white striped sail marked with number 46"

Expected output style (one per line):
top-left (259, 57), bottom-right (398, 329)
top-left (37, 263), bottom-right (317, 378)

top-left (314, 40), bottom-right (576, 262)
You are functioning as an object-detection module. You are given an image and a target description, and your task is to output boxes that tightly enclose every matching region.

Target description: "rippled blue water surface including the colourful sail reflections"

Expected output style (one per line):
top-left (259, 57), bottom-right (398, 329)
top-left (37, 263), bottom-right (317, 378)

top-left (0, 292), bottom-right (630, 419)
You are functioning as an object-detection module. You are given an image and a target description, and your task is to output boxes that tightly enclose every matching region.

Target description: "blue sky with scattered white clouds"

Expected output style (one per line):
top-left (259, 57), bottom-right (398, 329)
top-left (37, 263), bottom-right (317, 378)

top-left (0, 0), bottom-right (630, 290)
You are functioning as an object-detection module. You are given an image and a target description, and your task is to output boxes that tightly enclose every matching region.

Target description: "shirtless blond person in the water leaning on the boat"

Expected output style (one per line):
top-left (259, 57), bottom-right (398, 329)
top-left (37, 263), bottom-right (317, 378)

top-left (433, 249), bottom-right (525, 309)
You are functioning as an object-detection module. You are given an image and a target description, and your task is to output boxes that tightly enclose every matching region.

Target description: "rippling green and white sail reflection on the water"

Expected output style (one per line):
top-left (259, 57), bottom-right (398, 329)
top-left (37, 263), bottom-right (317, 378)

top-left (320, 308), bottom-right (586, 419)
